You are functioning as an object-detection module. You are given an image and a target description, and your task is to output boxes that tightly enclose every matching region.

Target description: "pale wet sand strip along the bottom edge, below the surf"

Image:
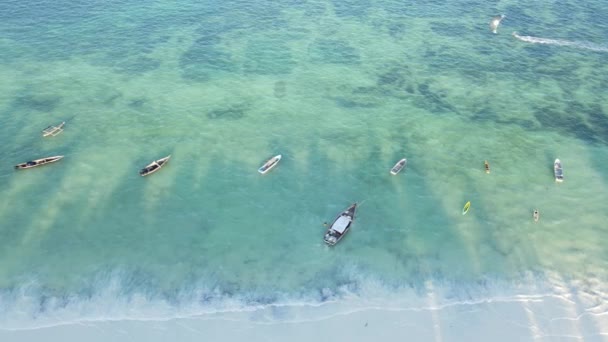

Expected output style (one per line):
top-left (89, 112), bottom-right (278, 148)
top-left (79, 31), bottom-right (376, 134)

top-left (0, 297), bottom-right (608, 342)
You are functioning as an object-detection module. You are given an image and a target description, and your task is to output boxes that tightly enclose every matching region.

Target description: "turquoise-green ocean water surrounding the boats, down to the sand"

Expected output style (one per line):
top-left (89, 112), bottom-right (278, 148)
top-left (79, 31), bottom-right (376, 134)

top-left (0, 0), bottom-right (608, 330)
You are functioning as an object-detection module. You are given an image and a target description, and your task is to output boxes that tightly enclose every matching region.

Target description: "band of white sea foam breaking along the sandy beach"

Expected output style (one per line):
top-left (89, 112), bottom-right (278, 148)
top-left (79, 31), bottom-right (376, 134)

top-left (0, 268), bottom-right (608, 336)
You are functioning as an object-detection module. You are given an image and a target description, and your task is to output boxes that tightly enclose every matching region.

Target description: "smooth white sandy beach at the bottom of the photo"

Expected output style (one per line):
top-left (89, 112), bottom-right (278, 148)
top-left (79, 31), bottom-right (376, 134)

top-left (0, 276), bottom-right (608, 342)
